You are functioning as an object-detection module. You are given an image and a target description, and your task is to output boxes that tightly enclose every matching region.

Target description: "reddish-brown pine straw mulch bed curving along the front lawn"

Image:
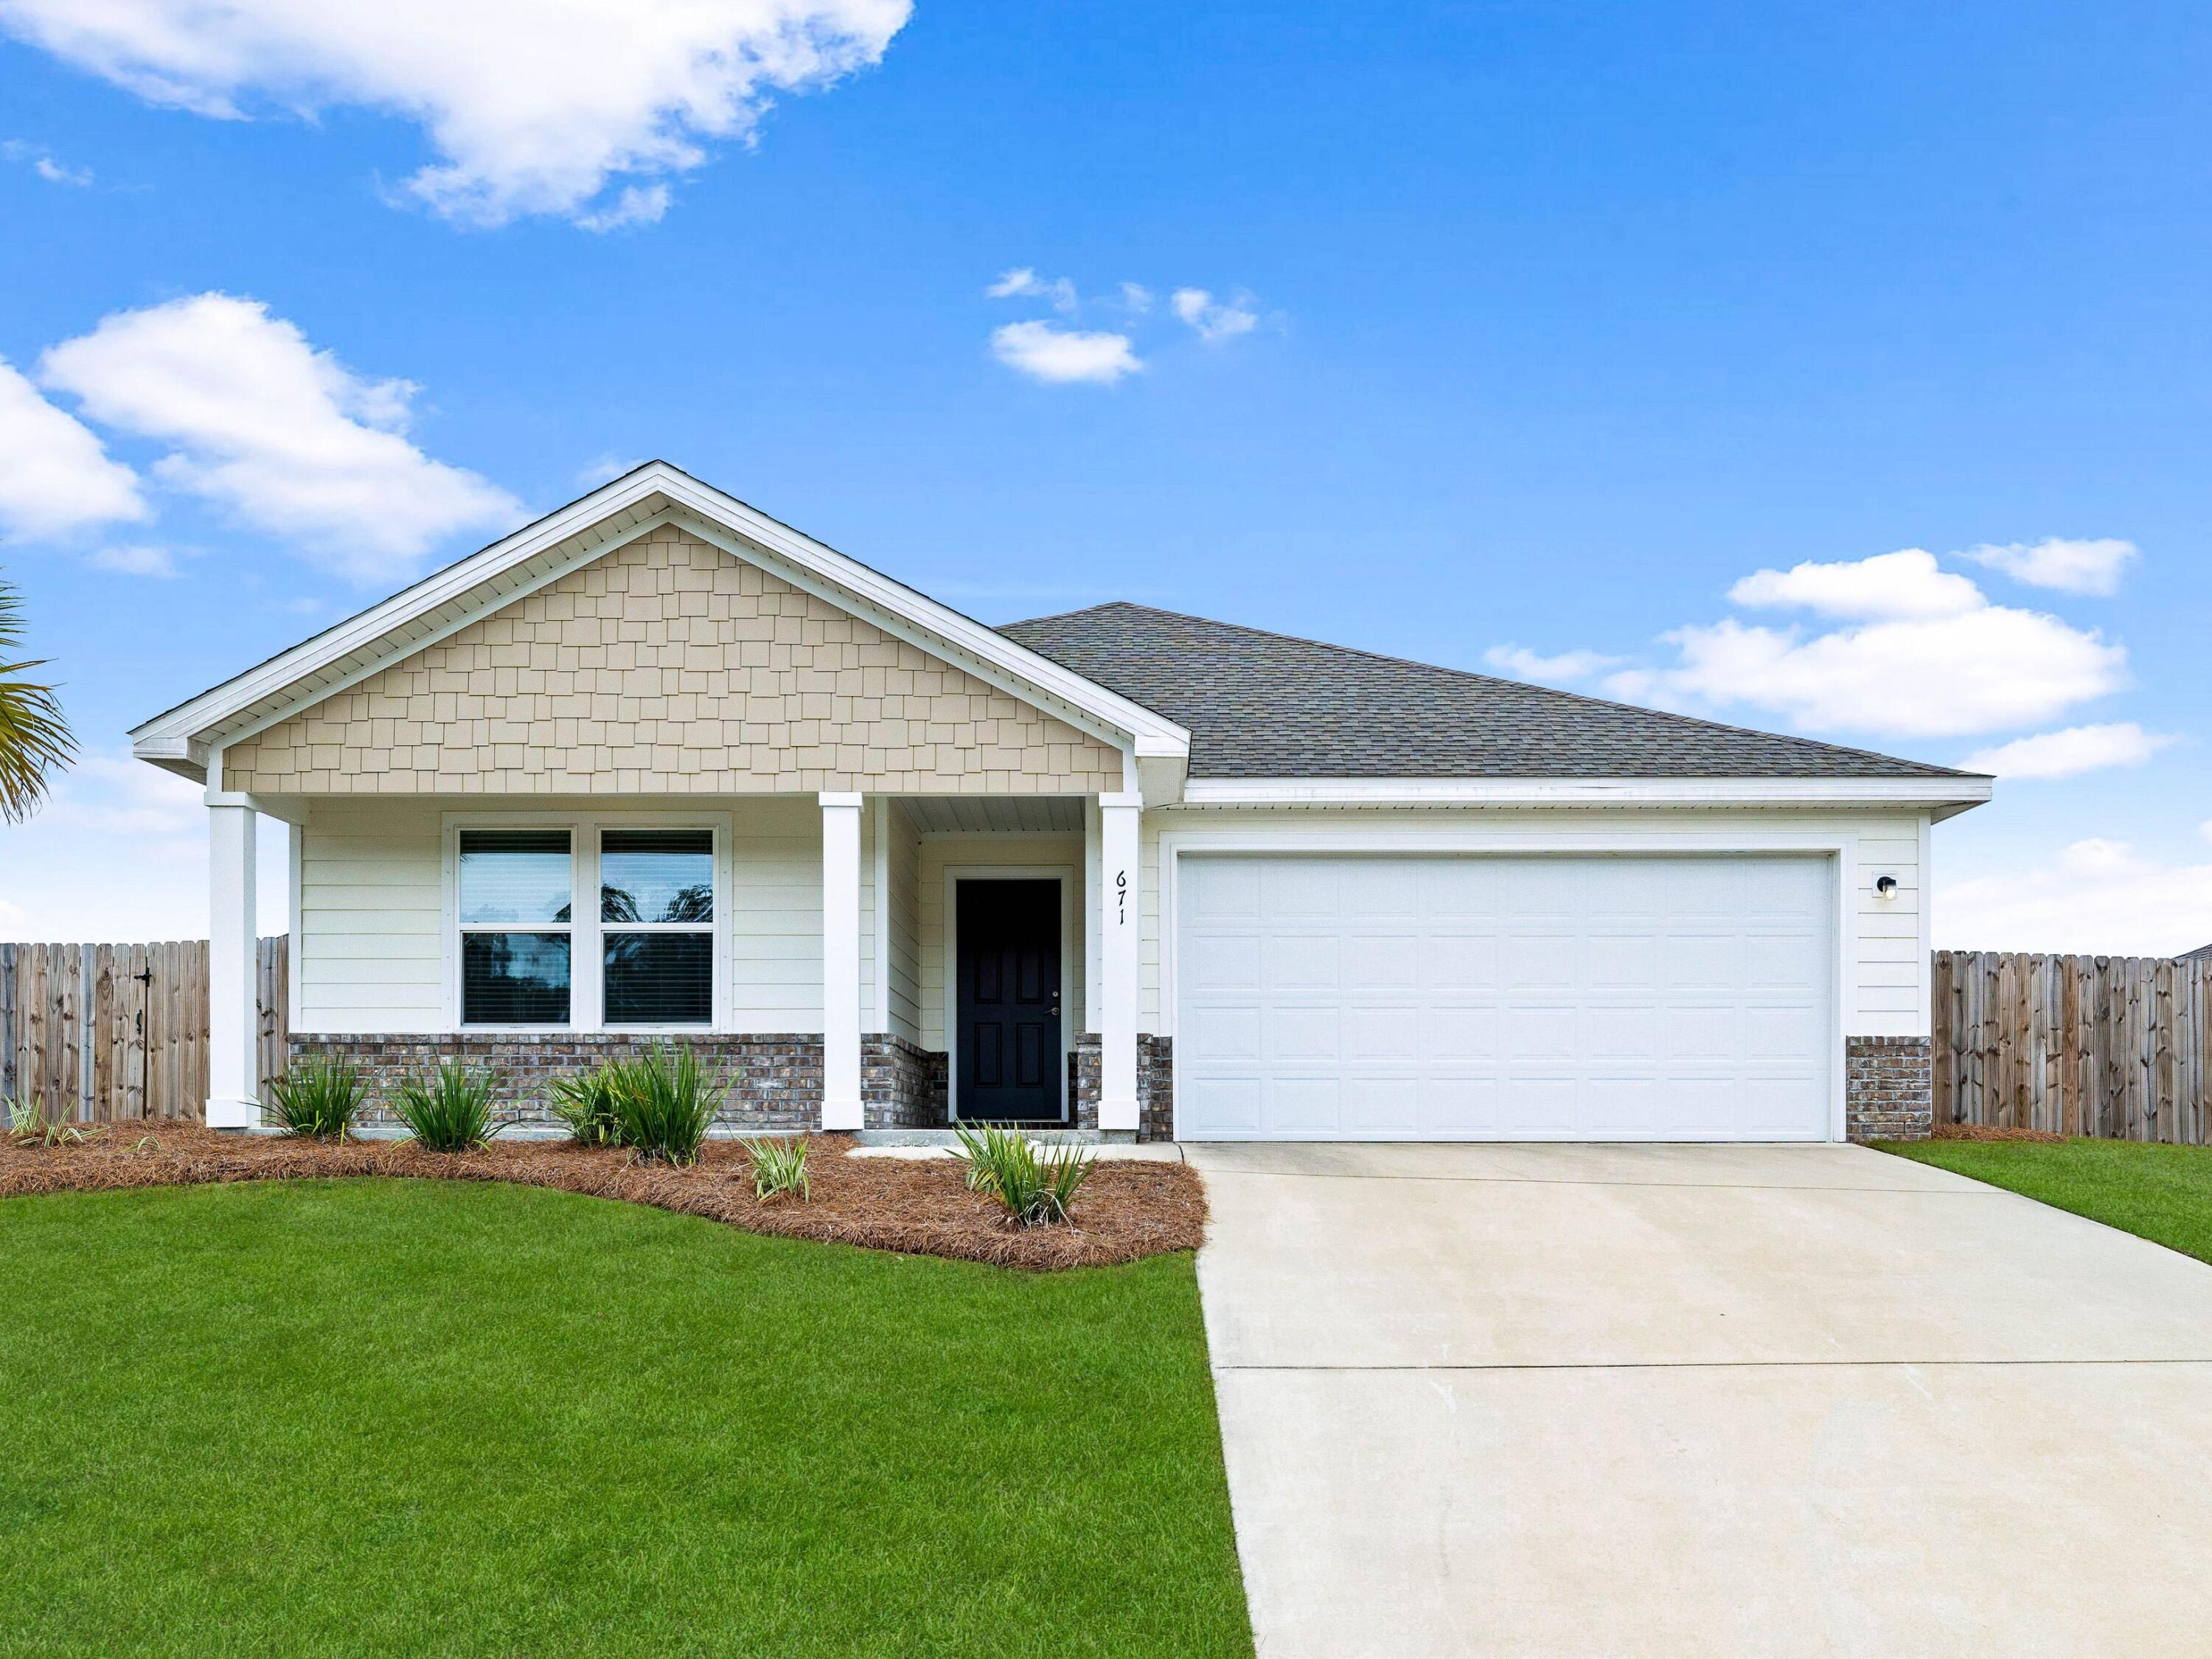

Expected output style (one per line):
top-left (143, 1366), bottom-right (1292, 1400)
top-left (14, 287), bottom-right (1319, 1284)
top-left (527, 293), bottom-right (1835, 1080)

top-left (0, 1124), bottom-right (1206, 1267)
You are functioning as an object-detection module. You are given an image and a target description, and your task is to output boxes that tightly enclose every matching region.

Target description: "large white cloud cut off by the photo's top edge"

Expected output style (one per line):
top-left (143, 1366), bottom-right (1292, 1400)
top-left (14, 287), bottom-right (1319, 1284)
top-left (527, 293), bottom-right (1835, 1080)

top-left (0, 0), bottom-right (911, 226)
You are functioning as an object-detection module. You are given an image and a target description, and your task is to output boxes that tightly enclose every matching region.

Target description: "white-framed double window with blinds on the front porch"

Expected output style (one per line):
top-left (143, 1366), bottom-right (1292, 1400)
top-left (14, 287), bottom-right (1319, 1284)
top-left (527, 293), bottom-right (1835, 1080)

top-left (458, 830), bottom-right (714, 1026)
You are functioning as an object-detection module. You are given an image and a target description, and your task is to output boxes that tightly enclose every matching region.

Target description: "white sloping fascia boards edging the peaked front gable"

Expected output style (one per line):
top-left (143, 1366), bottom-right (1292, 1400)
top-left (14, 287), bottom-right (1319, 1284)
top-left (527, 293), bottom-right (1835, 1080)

top-left (131, 462), bottom-right (1190, 770)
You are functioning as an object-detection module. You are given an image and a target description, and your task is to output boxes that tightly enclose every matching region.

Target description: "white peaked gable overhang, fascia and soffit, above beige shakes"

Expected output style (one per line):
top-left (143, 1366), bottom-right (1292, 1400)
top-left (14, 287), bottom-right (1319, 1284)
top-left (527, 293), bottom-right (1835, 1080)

top-left (131, 460), bottom-right (1188, 779)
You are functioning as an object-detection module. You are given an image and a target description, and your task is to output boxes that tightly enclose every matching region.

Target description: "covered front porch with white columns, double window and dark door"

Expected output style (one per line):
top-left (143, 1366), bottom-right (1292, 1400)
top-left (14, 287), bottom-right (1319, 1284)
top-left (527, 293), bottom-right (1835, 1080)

top-left (208, 790), bottom-right (1172, 1139)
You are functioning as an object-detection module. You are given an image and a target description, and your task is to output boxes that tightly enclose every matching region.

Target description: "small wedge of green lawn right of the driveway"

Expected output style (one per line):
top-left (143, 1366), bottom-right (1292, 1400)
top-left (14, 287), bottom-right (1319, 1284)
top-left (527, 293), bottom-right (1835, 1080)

top-left (1882, 1141), bottom-right (2212, 1261)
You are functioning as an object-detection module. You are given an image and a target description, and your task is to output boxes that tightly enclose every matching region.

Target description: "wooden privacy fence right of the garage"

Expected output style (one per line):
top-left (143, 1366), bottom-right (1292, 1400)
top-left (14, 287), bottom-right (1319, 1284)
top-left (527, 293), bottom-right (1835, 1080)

top-left (1933, 951), bottom-right (2212, 1146)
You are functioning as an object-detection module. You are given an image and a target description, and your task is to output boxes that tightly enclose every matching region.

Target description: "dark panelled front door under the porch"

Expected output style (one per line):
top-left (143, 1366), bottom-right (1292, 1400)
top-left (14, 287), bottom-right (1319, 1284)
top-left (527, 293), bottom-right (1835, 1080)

top-left (953, 880), bottom-right (1064, 1124)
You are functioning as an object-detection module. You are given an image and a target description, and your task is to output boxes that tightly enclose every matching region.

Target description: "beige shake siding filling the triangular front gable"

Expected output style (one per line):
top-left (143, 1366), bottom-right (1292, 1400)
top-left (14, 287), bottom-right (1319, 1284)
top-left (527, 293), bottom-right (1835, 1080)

top-left (223, 526), bottom-right (1121, 799)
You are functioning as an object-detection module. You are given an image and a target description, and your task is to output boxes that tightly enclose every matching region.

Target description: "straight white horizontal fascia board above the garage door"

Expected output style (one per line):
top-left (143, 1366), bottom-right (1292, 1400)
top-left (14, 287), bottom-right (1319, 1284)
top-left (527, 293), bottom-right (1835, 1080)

top-left (1183, 776), bottom-right (1991, 812)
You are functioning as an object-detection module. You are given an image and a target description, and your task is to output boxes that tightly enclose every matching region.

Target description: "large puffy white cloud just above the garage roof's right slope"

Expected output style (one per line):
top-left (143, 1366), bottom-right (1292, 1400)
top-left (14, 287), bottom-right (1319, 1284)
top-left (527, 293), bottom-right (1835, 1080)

top-left (1606, 549), bottom-right (2128, 737)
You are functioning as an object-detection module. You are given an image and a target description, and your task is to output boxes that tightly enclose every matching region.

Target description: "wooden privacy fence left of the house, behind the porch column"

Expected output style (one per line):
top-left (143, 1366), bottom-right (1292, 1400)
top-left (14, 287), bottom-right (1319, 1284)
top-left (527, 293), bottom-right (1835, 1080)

top-left (0, 933), bottom-right (290, 1124)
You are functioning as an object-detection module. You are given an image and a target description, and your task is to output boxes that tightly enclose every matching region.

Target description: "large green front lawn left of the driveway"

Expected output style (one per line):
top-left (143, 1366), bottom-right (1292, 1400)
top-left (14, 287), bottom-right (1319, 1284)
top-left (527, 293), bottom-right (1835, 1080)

top-left (0, 1181), bottom-right (1252, 1655)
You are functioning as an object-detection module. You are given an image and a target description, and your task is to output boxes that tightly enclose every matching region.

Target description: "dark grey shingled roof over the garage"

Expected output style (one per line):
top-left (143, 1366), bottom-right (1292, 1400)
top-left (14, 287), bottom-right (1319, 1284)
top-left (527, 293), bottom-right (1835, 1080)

top-left (1000, 604), bottom-right (1984, 783)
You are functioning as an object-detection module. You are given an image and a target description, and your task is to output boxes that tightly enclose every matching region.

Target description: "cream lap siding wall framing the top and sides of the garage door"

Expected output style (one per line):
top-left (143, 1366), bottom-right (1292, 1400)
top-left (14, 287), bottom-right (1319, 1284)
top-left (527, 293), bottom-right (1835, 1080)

top-left (1139, 807), bottom-right (1927, 1037)
